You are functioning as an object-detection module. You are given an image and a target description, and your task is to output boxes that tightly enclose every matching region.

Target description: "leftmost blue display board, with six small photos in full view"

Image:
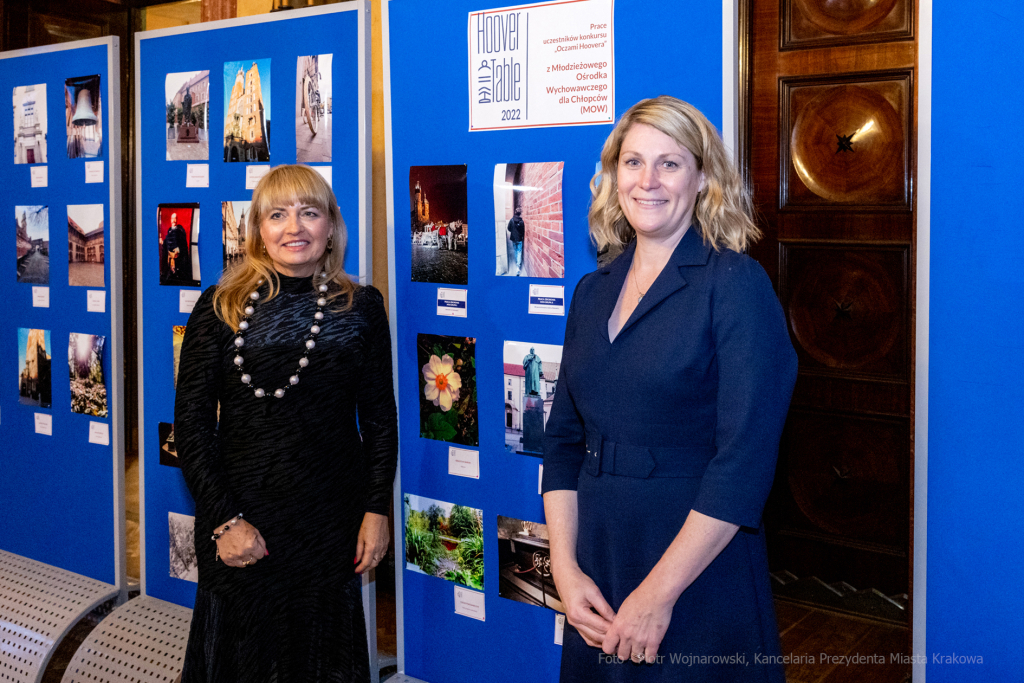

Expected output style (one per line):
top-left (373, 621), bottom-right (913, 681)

top-left (0, 38), bottom-right (125, 588)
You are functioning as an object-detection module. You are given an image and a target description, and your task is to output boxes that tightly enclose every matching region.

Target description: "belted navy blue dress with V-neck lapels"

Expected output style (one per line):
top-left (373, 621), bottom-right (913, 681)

top-left (543, 227), bottom-right (797, 683)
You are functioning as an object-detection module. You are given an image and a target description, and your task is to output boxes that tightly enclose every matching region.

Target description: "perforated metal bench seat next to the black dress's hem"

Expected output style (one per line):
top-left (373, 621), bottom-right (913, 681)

top-left (60, 595), bottom-right (193, 683)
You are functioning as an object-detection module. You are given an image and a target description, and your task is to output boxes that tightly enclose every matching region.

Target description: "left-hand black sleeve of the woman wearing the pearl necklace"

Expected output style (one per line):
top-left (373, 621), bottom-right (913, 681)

top-left (174, 287), bottom-right (243, 531)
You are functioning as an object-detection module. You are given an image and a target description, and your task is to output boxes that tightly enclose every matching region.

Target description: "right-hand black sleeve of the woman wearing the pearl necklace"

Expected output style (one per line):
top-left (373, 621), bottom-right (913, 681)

top-left (357, 287), bottom-right (398, 515)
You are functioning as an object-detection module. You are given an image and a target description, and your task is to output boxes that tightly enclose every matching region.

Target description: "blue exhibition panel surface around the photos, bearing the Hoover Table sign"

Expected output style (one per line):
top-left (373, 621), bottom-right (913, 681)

top-left (385, 0), bottom-right (723, 683)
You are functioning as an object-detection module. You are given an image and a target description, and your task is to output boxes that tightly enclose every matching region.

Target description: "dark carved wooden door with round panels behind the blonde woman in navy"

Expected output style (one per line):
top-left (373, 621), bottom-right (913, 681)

top-left (740, 0), bottom-right (916, 616)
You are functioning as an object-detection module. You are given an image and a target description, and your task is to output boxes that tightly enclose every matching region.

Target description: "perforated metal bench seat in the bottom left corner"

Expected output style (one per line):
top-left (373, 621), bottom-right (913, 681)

top-left (0, 550), bottom-right (118, 683)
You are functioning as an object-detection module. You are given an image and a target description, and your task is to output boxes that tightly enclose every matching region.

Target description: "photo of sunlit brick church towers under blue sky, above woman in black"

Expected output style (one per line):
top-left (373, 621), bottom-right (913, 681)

top-left (224, 59), bottom-right (270, 162)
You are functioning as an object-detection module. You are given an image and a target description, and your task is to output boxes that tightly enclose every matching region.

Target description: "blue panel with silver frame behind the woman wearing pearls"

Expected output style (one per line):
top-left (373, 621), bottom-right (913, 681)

top-left (136, 2), bottom-right (369, 607)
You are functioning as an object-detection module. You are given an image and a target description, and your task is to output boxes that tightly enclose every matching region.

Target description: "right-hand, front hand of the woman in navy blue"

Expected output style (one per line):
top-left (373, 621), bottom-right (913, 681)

top-left (601, 581), bottom-right (676, 664)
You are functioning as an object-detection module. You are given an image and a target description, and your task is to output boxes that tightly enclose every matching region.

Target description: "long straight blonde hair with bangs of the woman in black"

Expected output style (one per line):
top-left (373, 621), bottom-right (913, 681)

top-left (213, 165), bottom-right (356, 330)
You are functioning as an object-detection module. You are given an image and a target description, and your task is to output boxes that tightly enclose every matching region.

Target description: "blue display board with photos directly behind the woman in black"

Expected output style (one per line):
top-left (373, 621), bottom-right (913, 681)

top-left (135, 0), bottom-right (370, 607)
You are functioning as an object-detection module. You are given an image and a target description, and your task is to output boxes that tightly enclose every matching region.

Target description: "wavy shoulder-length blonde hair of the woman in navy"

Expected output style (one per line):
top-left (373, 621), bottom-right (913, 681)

top-left (589, 95), bottom-right (761, 252)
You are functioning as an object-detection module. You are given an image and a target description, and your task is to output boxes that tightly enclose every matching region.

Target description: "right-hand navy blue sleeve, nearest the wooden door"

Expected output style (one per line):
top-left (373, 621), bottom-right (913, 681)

top-left (693, 255), bottom-right (797, 528)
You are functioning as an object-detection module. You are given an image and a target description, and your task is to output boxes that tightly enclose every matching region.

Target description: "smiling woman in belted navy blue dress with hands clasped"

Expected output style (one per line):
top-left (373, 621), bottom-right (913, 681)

top-left (544, 96), bottom-right (797, 683)
